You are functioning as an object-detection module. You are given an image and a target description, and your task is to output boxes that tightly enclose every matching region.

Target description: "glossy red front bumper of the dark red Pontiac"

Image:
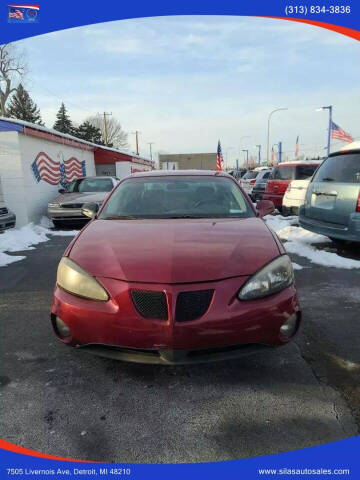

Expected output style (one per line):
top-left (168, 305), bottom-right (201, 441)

top-left (51, 277), bottom-right (301, 363)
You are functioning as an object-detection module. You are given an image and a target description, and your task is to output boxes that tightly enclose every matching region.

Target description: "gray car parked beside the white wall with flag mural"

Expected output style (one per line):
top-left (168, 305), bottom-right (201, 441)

top-left (48, 177), bottom-right (119, 227)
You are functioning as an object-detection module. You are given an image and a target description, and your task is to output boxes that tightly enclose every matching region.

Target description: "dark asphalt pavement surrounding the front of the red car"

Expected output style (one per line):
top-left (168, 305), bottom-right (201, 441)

top-left (0, 237), bottom-right (360, 463)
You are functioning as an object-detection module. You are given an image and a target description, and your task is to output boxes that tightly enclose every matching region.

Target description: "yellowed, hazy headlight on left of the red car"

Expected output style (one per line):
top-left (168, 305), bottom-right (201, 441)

top-left (56, 257), bottom-right (109, 302)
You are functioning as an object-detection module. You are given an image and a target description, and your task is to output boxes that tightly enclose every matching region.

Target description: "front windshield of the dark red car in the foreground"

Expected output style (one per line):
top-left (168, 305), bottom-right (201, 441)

top-left (99, 176), bottom-right (255, 219)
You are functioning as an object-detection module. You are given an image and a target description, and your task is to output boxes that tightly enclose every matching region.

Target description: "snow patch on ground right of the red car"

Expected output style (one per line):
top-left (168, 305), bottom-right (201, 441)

top-left (264, 215), bottom-right (360, 270)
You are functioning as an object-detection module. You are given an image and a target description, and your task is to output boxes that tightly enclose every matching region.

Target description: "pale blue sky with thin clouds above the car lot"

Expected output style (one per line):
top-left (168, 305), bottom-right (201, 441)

top-left (18, 16), bottom-right (360, 166)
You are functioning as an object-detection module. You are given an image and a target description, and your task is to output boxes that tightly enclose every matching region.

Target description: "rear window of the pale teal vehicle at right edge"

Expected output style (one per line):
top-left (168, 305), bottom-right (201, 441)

top-left (313, 153), bottom-right (360, 183)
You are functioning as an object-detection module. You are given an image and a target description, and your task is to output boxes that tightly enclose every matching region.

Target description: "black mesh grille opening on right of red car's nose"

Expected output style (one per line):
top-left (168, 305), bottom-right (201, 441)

top-left (175, 290), bottom-right (214, 322)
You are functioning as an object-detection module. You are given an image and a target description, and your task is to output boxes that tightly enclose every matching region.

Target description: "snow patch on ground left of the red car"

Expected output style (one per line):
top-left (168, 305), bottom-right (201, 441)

top-left (0, 217), bottom-right (78, 267)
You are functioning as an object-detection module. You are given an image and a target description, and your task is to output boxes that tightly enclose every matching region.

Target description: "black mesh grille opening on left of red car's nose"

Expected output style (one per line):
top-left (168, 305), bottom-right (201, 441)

top-left (130, 290), bottom-right (168, 320)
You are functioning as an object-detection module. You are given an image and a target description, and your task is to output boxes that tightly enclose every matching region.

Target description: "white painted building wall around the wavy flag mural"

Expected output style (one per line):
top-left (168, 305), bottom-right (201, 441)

top-left (0, 132), bottom-right (96, 227)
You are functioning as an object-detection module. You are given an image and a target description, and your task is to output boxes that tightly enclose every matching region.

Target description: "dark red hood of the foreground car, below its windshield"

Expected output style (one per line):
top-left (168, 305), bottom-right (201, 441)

top-left (69, 217), bottom-right (280, 284)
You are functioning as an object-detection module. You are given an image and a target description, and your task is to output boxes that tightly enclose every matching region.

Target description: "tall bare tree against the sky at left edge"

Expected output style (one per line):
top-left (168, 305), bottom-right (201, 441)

top-left (0, 43), bottom-right (26, 117)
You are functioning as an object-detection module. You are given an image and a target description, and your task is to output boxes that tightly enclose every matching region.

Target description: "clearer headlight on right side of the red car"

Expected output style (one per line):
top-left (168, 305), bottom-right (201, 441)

top-left (238, 255), bottom-right (294, 300)
